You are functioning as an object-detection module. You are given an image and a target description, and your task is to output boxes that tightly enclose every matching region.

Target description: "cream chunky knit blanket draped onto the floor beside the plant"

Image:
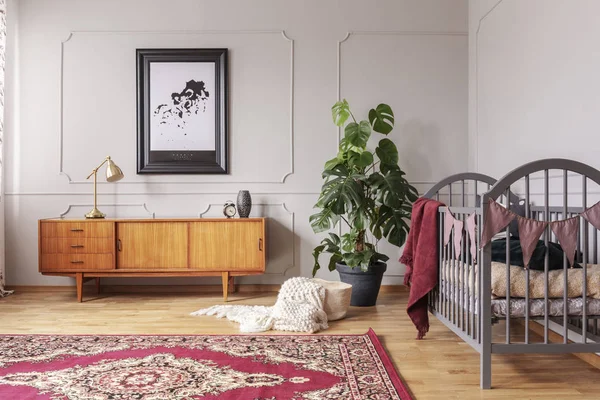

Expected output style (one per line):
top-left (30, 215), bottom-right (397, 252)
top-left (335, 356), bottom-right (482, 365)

top-left (191, 277), bottom-right (328, 333)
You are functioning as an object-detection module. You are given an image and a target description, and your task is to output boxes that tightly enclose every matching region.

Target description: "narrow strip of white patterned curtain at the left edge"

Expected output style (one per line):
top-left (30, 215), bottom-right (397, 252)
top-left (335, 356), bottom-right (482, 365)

top-left (0, 0), bottom-right (12, 297)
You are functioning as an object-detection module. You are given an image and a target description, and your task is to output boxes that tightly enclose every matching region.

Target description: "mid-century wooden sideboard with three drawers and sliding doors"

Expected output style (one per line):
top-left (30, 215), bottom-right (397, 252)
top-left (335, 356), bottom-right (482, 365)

top-left (38, 218), bottom-right (266, 302)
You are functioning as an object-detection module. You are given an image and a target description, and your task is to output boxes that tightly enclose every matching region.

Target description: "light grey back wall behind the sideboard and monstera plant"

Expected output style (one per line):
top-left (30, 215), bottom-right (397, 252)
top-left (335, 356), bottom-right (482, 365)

top-left (5, 0), bottom-right (468, 285)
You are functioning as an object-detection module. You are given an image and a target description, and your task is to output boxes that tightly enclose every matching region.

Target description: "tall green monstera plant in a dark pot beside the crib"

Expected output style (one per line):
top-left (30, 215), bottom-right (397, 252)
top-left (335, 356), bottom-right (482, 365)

top-left (310, 100), bottom-right (418, 306)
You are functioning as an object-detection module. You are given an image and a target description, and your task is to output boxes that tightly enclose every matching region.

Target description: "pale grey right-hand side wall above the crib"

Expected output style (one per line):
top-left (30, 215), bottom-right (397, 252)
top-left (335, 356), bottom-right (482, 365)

top-left (469, 0), bottom-right (600, 177)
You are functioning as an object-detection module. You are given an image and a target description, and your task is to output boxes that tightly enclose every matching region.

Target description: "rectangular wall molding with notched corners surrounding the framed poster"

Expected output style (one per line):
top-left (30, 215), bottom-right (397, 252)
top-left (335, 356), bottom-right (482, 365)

top-left (58, 30), bottom-right (295, 186)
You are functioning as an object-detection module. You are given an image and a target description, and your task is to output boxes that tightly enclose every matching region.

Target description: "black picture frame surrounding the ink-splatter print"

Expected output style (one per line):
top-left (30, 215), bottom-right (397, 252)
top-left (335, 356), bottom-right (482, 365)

top-left (136, 48), bottom-right (228, 174)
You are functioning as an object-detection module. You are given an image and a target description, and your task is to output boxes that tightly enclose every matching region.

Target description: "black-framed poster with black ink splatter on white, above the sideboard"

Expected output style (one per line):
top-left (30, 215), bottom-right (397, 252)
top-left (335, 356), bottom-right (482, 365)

top-left (137, 49), bottom-right (227, 174)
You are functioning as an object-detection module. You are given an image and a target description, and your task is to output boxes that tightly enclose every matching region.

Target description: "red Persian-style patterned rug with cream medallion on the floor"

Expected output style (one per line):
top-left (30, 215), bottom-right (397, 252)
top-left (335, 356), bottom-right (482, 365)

top-left (0, 330), bottom-right (411, 400)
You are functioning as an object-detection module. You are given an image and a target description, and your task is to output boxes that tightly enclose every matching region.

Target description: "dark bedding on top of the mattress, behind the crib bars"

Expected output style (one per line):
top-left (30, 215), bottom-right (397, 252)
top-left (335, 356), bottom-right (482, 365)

top-left (492, 238), bottom-right (581, 271)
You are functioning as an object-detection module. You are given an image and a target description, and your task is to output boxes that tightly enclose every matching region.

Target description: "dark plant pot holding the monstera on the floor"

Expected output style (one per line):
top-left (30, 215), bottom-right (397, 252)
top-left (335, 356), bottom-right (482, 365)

top-left (335, 262), bottom-right (387, 307)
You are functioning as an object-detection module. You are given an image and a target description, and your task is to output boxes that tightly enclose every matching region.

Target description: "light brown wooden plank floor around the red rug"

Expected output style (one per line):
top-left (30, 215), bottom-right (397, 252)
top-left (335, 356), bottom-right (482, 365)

top-left (0, 289), bottom-right (600, 399)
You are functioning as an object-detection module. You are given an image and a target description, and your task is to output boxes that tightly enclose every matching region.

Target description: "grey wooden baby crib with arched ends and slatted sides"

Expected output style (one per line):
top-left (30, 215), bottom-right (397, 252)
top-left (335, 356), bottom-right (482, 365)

top-left (425, 159), bottom-right (600, 389)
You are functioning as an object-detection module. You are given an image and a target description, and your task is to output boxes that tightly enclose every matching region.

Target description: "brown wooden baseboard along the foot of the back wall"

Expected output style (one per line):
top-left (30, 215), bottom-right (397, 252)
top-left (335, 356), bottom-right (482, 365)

top-left (6, 284), bottom-right (408, 293)
